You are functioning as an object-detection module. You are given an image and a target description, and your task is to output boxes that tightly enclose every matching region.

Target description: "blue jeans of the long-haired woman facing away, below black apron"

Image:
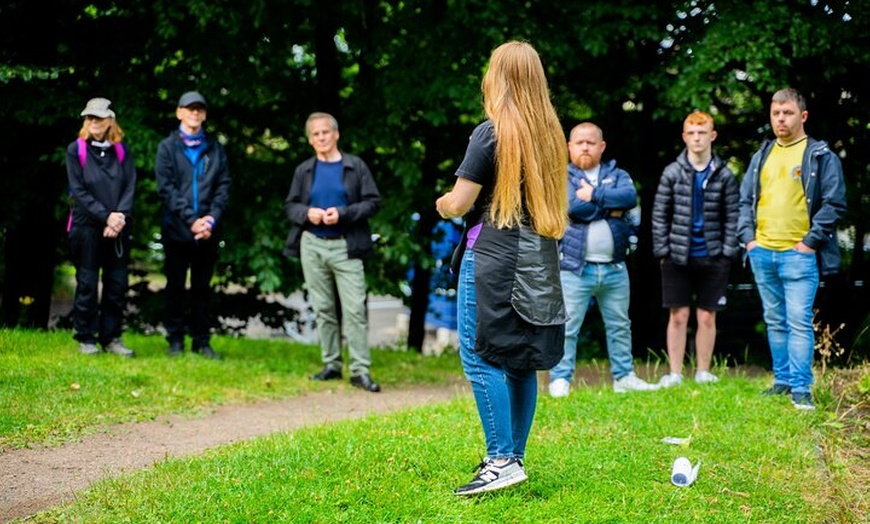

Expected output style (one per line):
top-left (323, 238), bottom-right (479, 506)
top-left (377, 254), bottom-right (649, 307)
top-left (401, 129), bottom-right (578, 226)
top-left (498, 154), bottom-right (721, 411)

top-left (456, 249), bottom-right (538, 459)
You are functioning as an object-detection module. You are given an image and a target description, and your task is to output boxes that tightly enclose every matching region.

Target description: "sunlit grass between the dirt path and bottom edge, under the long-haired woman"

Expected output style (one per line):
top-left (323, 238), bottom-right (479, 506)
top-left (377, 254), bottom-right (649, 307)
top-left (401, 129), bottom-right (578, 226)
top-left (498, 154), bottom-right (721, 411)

top-left (35, 377), bottom-right (836, 523)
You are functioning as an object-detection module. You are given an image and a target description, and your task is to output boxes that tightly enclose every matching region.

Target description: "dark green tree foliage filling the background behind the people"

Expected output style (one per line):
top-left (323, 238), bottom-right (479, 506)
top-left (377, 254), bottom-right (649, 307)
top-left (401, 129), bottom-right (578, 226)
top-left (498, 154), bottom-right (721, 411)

top-left (0, 0), bottom-right (870, 358)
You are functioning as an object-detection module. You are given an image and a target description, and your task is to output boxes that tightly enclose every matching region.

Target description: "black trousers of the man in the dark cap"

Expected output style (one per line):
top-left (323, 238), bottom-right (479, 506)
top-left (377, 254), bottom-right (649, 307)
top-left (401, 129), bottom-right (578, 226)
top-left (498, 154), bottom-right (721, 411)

top-left (163, 237), bottom-right (218, 349)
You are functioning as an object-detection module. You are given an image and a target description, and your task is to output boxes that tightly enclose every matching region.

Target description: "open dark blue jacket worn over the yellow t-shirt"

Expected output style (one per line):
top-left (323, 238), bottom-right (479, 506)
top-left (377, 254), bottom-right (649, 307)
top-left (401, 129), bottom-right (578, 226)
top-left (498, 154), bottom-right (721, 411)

top-left (737, 137), bottom-right (846, 275)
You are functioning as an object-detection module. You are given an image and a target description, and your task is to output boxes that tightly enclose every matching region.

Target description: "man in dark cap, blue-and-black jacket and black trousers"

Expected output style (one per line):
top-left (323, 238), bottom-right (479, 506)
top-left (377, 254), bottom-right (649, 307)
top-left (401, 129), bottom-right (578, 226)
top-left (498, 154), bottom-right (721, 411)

top-left (154, 91), bottom-right (230, 359)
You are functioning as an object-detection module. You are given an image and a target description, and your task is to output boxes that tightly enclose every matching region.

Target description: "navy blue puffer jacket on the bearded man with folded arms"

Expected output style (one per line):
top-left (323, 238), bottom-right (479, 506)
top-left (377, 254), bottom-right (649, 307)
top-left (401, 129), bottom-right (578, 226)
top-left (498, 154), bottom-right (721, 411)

top-left (559, 160), bottom-right (637, 271)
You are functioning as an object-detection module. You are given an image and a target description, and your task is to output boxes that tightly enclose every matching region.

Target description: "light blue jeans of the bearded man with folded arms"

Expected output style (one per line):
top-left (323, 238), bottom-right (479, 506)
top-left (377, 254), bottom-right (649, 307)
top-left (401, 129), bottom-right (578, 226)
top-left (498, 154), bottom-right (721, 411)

top-left (550, 262), bottom-right (634, 382)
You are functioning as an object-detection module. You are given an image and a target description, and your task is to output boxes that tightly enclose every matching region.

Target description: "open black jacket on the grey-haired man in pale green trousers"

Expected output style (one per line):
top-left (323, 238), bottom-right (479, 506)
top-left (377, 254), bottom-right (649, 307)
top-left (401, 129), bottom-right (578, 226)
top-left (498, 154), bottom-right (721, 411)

top-left (284, 152), bottom-right (381, 258)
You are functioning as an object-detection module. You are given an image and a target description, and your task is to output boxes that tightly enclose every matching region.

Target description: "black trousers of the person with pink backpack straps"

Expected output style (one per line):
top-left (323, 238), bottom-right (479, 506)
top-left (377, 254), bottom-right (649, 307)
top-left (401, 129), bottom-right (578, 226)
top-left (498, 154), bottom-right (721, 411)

top-left (69, 224), bottom-right (130, 345)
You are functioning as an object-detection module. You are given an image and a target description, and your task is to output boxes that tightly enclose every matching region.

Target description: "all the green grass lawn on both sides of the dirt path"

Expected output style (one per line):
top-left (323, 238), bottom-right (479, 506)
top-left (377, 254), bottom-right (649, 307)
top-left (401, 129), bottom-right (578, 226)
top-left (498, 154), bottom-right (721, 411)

top-left (0, 331), bottom-right (870, 523)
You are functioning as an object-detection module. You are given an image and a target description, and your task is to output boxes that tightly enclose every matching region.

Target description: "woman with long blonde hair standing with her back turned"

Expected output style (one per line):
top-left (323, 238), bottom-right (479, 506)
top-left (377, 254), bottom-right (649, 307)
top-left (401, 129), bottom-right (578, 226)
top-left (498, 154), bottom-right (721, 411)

top-left (436, 41), bottom-right (568, 495)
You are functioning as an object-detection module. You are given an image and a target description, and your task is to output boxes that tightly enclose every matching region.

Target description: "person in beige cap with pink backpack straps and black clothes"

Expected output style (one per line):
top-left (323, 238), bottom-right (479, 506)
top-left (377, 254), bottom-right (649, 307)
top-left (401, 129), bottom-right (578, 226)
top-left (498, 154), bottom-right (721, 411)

top-left (66, 98), bottom-right (136, 357)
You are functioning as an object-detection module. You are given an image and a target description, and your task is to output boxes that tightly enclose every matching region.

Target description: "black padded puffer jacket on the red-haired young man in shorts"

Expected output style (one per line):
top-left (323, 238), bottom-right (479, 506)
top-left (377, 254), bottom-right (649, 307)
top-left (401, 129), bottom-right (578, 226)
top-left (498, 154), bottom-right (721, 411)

top-left (652, 150), bottom-right (739, 266)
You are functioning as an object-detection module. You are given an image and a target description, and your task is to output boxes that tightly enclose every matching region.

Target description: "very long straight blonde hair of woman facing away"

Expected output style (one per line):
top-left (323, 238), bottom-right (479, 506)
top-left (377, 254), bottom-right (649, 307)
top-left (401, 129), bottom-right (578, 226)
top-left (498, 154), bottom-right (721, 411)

top-left (481, 41), bottom-right (568, 239)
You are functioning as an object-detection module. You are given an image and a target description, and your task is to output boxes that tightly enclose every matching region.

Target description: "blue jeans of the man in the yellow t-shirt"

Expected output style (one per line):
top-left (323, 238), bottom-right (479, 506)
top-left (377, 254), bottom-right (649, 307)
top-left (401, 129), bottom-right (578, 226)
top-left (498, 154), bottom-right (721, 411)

top-left (749, 246), bottom-right (819, 393)
